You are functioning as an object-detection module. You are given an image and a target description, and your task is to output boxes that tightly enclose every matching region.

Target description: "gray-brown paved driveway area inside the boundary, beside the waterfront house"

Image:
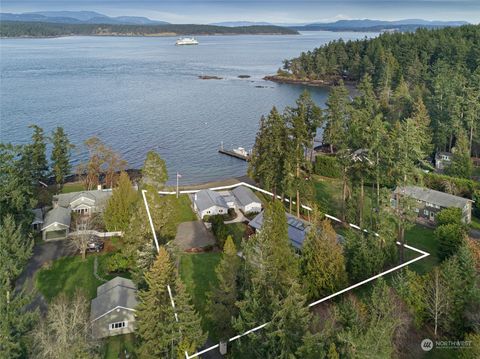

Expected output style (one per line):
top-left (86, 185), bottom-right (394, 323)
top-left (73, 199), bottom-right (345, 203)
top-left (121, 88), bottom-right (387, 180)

top-left (175, 221), bottom-right (215, 250)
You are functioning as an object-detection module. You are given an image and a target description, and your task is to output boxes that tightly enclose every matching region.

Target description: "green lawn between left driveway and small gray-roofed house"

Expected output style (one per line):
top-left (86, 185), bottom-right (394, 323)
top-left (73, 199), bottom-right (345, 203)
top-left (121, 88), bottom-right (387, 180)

top-left (36, 255), bottom-right (102, 302)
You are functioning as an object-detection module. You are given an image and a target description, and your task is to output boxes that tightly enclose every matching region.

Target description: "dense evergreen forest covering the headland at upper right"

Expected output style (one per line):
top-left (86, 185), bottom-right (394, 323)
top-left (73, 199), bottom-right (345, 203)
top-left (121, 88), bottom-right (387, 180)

top-left (278, 25), bottom-right (480, 156)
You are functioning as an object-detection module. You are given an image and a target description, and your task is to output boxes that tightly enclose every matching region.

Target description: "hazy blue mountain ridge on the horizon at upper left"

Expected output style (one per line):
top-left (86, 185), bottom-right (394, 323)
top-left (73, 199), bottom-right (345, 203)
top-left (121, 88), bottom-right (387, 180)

top-left (0, 11), bottom-right (168, 25)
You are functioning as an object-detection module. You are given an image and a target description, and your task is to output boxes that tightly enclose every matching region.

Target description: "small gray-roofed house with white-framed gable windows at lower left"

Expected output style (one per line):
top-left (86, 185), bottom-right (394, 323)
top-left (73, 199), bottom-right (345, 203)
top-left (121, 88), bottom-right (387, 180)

top-left (90, 277), bottom-right (138, 339)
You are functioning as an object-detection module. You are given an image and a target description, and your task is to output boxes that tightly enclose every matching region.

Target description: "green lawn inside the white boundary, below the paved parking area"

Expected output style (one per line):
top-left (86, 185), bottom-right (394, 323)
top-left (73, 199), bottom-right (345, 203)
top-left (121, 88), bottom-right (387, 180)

top-left (180, 252), bottom-right (222, 333)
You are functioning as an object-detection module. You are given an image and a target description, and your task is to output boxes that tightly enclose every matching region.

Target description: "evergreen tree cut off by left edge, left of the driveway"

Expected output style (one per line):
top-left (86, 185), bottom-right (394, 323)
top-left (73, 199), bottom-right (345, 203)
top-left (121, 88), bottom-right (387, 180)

top-left (0, 214), bottom-right (33, 286)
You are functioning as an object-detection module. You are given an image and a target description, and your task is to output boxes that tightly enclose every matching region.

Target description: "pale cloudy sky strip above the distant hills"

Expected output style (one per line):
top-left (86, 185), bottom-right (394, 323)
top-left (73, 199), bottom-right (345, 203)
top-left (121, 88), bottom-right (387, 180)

top-left (1, 0), bottom-right (480, 24)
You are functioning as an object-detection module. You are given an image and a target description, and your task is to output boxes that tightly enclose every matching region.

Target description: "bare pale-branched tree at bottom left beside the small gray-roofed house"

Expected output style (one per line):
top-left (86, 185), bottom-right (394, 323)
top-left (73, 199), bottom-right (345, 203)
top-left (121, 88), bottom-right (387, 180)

top-left (32, 292), bottom-right (99, 359)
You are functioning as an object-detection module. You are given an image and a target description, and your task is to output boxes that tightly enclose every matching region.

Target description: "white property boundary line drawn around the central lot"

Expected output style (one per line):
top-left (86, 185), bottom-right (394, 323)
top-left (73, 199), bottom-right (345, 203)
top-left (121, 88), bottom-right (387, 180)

top-left (142, 182), bottom-right (430, 359)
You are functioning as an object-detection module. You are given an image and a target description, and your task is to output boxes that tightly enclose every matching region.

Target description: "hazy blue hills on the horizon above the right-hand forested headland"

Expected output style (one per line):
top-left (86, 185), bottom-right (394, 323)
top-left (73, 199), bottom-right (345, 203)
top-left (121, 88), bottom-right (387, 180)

top-left (291, 19), bottom-right (468, 31)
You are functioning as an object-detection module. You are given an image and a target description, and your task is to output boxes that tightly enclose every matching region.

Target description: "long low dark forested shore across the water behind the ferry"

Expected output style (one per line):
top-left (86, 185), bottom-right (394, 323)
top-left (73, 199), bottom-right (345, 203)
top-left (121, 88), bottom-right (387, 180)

top-left (0, 21), bottom-right (298, 37)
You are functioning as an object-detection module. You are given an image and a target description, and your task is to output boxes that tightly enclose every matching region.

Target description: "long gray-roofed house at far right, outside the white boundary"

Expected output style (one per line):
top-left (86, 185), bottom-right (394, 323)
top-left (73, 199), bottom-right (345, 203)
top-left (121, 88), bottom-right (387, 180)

top-left (392, 186), bottom-right (473, 223)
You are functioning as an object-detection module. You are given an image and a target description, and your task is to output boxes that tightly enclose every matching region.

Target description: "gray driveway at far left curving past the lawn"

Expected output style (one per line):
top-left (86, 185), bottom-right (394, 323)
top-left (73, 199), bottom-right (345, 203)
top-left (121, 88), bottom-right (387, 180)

top-left (15, 240), bottom-right (75, 311)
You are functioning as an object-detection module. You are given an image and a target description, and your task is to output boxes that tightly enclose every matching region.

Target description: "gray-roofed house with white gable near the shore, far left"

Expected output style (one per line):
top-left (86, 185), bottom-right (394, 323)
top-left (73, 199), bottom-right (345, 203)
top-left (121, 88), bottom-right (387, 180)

top-left (53, 189), bottom-right (112, 215)
